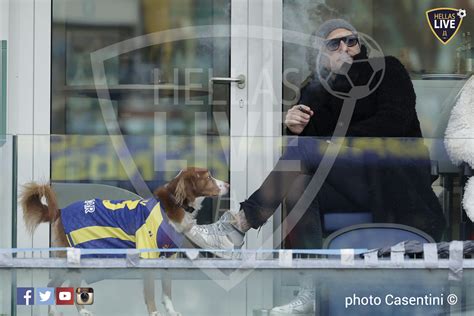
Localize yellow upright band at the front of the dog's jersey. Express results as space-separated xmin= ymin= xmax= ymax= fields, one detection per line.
xmin=135 ymin=203 xmax=163 ymax=259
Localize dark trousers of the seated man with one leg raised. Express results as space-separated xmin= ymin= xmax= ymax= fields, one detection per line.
xmin=241 ymin=137 xmax=375 ymax=228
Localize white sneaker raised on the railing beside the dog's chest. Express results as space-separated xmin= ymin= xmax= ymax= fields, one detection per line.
xmin=184 ymin=211 xmax=245 ymax=258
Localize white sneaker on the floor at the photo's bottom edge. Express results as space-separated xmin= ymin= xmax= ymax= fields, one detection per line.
xmin=270 ymin=287 xmax=316 ymax=316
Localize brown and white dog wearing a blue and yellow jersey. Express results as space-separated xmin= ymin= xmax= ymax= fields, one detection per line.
xmin=20 ymin=167 xmax=229 ymax=316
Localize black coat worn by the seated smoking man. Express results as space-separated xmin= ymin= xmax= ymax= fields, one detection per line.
xmin=287 ymin=48 xmax=445 ymax=240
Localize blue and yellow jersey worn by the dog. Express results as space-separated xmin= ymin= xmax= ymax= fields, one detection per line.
xmin=61 ymin=199 xmax=183 ymax=258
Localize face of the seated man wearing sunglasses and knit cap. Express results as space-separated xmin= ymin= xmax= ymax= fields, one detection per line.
xmin=324 ymin=29 xmax=360 ymax=73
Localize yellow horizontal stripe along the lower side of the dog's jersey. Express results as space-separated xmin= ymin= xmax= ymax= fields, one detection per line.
xmin=69 ymin=226 xmax=135 ymax=245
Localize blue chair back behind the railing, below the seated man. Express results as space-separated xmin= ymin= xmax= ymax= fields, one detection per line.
xmin=318 ymin=223 xmax=438 ymax=315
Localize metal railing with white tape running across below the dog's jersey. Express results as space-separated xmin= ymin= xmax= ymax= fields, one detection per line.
xmin=0 ymin=244 xmax=474 ymax=269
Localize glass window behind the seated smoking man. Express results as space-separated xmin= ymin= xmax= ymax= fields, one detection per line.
xmin=283 ymin=0 xmax=474 ymax=238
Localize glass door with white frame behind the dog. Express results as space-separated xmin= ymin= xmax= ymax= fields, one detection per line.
xmin=51 ymin=0 xmax=247 ymax=223
